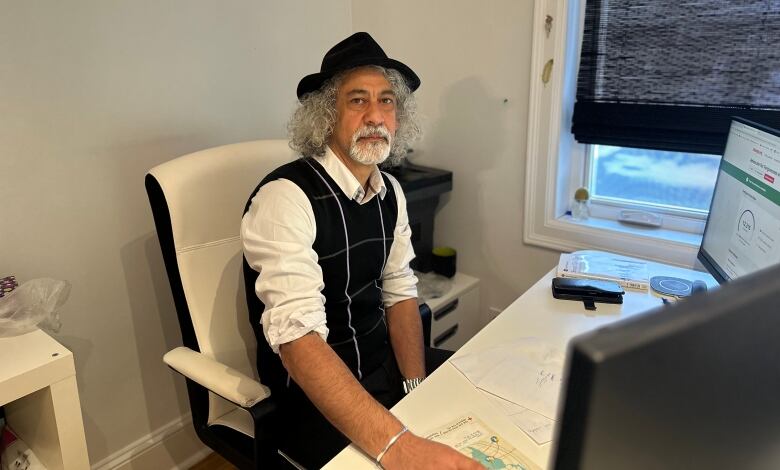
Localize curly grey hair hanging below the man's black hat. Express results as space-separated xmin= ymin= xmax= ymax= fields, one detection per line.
xmin=287 ymin=65 xmax=422 ymax=166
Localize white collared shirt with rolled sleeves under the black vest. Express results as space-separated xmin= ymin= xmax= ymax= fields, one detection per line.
xmin=241 ymin=148 xmax=417 ymax=354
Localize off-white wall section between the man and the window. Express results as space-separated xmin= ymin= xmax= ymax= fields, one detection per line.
xmin=352 ymin=0 xmax=558 ymax=326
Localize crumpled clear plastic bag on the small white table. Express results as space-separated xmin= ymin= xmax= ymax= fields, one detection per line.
xmin=0 ymin=278 xmax=70 ymax=338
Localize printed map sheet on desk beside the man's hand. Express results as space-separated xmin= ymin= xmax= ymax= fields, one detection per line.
xmin=426 ymin=415 xmax=539 ymax=470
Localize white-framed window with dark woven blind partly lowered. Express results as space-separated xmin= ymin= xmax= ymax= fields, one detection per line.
xmin=524 ymin=0 xmax=780 ymax=266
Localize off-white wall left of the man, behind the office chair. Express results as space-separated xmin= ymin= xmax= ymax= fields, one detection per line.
xmin=0 ymin=0 xmax=351 ymax=468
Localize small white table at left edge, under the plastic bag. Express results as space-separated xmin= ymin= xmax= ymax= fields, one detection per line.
xmin=0 ymin=330 xmax=89 ymax=470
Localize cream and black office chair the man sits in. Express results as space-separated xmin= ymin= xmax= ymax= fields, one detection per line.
xmin=146 ymin=140 xmax=296 ymax=469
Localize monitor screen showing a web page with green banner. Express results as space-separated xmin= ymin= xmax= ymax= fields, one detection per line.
xmin=698 ymin=118 xmax=780 ymax=283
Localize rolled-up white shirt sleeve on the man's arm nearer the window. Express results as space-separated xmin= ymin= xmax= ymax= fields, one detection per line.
xmin=382 ymin=176 xmax=417 ymax=308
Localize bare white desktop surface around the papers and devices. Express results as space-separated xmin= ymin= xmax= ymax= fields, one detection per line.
xmin=324 ymin=263 xmax=717 ymax=470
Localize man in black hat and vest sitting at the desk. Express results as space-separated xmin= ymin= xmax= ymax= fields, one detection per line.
xmin=241 ymin=33 xmax=481 ymax=469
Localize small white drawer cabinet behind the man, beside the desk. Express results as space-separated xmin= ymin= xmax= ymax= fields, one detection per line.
xmin=424 ymin=273 xmax=479 ymax=351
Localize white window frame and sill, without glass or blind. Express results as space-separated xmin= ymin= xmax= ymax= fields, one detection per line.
xmin=523 ymin=0 xmax=703 ymax=268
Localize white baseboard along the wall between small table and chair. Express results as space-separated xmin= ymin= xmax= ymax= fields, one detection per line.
xmin=91 ymin=413 xmax=212 ymax=470
